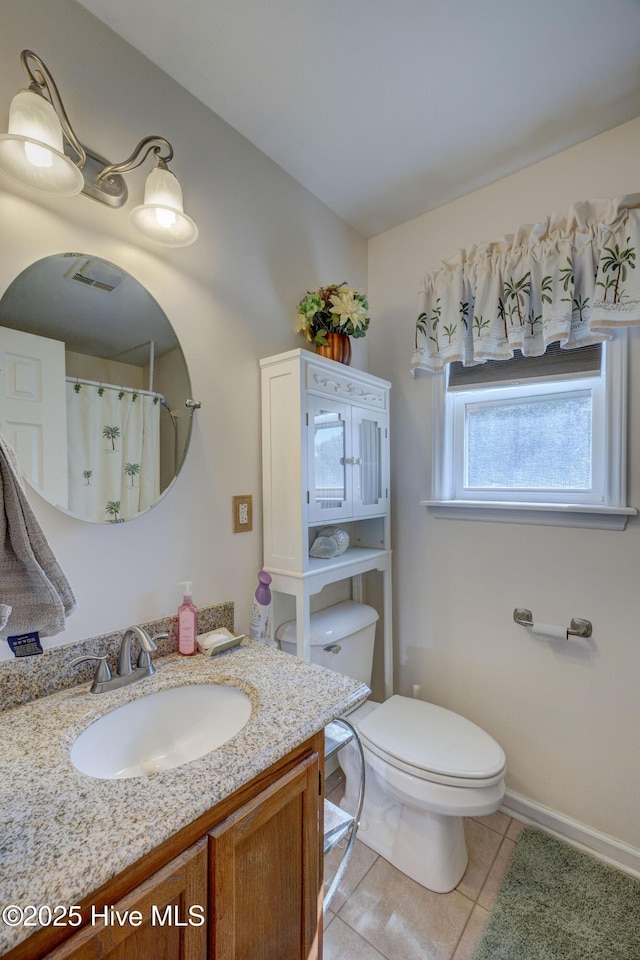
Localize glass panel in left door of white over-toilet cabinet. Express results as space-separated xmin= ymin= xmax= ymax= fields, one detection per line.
xmin=313 ymin=403 xmax=348 ymax=519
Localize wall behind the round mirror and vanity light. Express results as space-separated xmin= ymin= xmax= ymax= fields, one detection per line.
xmin=0 ymin=0 xmax=366 ymax=655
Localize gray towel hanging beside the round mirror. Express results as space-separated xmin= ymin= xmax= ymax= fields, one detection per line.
xmin=0 ymin=434 xmax=76 ymax=637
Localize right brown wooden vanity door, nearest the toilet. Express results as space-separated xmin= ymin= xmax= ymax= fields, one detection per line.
xmin=209 ymin=753 xmax=322 ymax=960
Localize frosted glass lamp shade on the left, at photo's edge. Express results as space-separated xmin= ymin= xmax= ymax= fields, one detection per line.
xmin=0 ymin=90 xmax=84 ymax=197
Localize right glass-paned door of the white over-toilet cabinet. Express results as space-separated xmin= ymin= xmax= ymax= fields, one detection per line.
xmin=351 ymin=407 xmax=389 ymax=517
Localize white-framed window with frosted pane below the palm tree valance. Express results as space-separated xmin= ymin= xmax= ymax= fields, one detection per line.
xmin=425 ymin=332 xmax=636 ymax=529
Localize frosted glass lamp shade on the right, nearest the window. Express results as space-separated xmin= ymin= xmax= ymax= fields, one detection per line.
xmin=129 ymin=167 xmax=198 ymax=247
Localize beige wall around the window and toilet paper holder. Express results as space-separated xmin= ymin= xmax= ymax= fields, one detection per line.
xmin=368 ymin=120 xmax=640 ymax=847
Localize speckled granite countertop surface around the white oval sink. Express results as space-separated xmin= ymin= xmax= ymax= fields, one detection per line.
xmin=0 ymin=640 xmax=369 ymax=956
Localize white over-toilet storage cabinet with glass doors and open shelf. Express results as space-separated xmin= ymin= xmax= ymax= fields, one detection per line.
xmin=260 ymin=350 xmax=393 ymax=697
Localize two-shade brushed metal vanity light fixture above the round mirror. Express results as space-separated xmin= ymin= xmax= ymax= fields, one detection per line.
xmin=0 ymin=50 xmax=198 ymax=247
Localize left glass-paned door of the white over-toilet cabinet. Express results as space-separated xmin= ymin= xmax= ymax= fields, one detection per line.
xmin=308 ymin=397 xmax=353 ymax=523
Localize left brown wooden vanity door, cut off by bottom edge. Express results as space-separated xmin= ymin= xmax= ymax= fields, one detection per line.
xmin=46 ymin=838 xmax=207 ymax=960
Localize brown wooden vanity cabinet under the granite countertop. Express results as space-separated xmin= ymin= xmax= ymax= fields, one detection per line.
xmin=4 ymin=733 xmax=324 ymax=960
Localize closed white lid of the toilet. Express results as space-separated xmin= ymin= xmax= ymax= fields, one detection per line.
xmin=358 ymin=695 xmax=505 ymax=780
